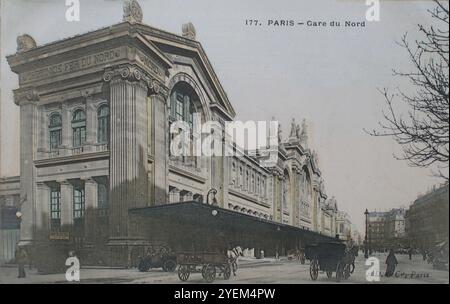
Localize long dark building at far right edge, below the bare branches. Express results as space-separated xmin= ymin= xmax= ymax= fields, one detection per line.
xmin=406 ymin=184 xmax=449 ymax=249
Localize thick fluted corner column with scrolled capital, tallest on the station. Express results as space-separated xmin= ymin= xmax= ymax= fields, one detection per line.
xmin=104 ymin=65 xmax=150 ymax=241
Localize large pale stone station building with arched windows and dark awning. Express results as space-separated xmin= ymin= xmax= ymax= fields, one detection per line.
xmin=2 ymin=4 xmax=337 ymax=266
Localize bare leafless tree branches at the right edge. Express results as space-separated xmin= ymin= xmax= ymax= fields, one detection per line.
xmin=368 ymin=0 xmax=449 ymax=182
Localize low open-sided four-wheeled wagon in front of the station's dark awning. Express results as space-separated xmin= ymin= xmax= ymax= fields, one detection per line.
xmin=177 ymin=251 xmax=235 ymax=283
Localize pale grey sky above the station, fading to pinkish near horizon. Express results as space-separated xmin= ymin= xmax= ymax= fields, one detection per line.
xmin=0 ymin=0 xmax=439 ymax=231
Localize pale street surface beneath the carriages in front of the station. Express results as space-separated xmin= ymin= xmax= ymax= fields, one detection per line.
xmin=0 ymin=254 xmax=449 ymax=284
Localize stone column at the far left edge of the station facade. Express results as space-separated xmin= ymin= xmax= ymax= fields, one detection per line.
xmin=14 ymin=89 xmax=39 ymax=245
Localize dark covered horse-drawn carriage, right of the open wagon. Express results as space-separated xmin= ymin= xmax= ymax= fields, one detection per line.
xmin=305 ymin=242 xmax=355 ymax=282
